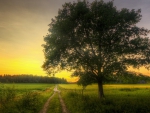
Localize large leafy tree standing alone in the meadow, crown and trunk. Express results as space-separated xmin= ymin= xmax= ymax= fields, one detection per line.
xmin=43 ymin=0 xmax=150 ymax=97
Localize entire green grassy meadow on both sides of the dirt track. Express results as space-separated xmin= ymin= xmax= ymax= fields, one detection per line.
xmin=0 ymin=83 xmax=150 ymax=113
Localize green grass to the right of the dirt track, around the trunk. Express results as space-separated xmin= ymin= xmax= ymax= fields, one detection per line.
xmin=59 ymin=84 xmax=150 ymax=113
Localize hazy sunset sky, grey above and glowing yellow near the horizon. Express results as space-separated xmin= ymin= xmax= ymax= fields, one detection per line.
xmin=0 ymin=0 xmax=150 ymax=80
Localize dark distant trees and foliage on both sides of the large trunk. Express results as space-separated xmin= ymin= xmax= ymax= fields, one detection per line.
xmin=77 ymin=71 xmax=150 ymax=87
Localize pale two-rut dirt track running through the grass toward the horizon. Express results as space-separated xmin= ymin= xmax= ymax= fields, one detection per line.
xmin=39 ymin=85 xmax=69 ymax=113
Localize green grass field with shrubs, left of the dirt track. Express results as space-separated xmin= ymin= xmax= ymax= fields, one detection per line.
xmin=0 ymin=83 xmax=55 ymax=113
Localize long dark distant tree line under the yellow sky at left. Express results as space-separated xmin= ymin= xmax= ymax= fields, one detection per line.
xmin=0 ymin=75 xmax=67 ymax=84
